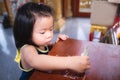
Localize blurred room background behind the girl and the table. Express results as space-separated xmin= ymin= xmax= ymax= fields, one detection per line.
xmin=0 ymin=0 xmax=120 ymax=80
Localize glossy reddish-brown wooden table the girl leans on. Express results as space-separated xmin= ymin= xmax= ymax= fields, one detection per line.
xmin=30 ymin=39 xmax=120 ymax=80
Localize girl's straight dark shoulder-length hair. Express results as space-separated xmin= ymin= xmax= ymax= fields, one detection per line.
xmin=13 ymin=2 xmax=53 ymax=49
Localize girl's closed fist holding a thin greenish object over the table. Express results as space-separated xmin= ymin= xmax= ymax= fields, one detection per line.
xmin=67 ymin=56 xmax=90 ymax=73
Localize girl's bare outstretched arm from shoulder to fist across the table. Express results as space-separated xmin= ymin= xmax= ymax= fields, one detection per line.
xmin=21 ymin=45 xmax=90 ymax=72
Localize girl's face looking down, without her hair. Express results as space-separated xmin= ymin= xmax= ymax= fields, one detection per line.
xmin=32 ymin=16 xmax=53 ymax=47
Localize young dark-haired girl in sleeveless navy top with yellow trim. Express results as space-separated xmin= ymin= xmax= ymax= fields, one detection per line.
xmin=13 ymin=2 xmax=90 ymax=80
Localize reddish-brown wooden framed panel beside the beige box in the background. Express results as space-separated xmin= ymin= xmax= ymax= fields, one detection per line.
xmin=71 ymin=0 xmax=92 ymax=17
